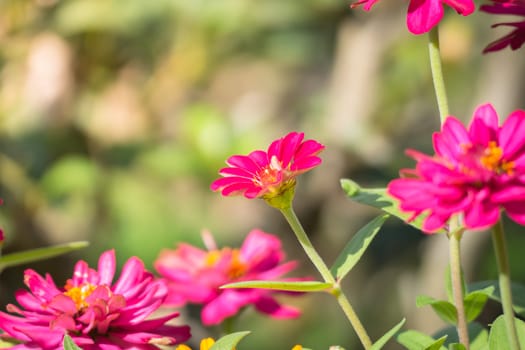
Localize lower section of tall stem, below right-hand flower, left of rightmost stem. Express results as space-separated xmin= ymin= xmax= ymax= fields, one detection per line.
xmin=449 ymin=228 xmax=470 ymax=350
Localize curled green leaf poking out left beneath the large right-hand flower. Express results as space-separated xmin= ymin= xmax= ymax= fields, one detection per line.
xmin=341 ymin=179 xmax=438 ymax=233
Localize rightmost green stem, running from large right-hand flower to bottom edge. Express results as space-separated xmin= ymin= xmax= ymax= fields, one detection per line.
xmin=492 ymin=221 xmax=520 ymax=350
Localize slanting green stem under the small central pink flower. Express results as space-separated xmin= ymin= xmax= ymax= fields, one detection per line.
xmin=279 ymin=206 xmax=372 ymax=349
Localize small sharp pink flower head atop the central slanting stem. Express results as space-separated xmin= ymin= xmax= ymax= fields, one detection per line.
xmin=211 ymin=132 xmax=324 ymax=198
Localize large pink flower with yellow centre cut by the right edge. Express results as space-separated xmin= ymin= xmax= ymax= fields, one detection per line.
xmin=388 ymin=104 xmax=525 ymax=232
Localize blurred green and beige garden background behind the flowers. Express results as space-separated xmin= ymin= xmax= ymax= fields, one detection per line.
xmin=0 ymin=0 xmax=525 ymax=350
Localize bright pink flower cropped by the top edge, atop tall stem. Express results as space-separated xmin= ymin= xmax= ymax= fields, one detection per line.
xmin=351 ymin=0 xmax=476 ymax=34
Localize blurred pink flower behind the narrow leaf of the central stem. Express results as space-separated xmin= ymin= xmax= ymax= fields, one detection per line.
xmin=154 ymin=230 xmax=300 ymax=325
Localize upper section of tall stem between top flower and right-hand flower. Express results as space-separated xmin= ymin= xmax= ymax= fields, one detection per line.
xmin=428 ymin=26 xmax=449 ymax=125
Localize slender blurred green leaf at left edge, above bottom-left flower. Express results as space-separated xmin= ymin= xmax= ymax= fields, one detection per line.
xmin=0 ymin=241 xmax=89 ymax=272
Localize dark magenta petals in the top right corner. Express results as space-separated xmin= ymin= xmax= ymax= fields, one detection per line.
xmin=480 ymin=0 xmax=525 ymax=53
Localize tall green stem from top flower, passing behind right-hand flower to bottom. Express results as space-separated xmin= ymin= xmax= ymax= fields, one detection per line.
xmin=428 ymin=25 xmax=470 ymax=350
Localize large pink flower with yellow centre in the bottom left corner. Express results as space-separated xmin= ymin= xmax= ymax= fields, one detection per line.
xmin=0 ymin=250 xmax=190 ymax=350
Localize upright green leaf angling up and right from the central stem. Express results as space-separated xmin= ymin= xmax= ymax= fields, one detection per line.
xmin=330 ymin=214 xmax=390 ymax=281
